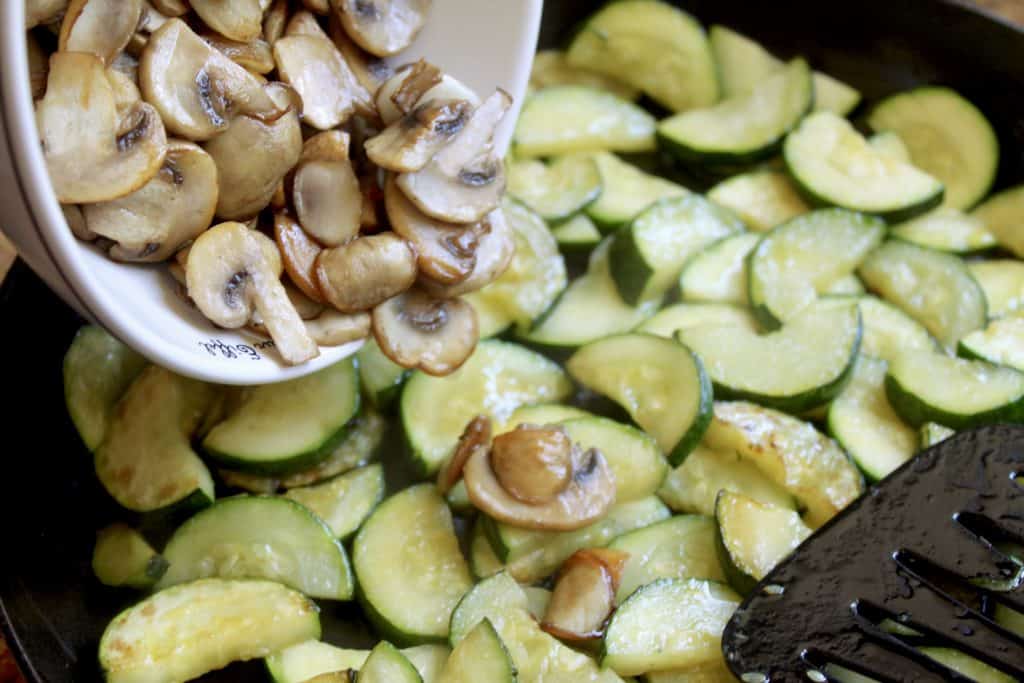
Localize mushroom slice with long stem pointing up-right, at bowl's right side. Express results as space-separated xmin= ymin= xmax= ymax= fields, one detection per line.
xmin=398 ymin=90 xmax=512 ymax=223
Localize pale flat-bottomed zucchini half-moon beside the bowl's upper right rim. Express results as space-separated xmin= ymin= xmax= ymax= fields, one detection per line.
xmin=512 ymin=85 xmax=656 ymax=159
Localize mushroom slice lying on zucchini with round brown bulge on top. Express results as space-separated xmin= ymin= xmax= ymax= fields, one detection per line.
xmin=463 ymin=425 xmax=615 ymax=531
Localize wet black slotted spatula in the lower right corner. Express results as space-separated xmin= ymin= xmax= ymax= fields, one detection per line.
xmin=723 ymin=425 xmax=1024 ymax=683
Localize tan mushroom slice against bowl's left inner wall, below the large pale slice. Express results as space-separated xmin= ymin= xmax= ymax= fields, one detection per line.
xmin=82 ymin=140 xmax=218 ymax=262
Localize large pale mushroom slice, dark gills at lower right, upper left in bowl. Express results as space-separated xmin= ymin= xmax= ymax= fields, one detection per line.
xmin=139 ymin=19 xmax=290 ymax=141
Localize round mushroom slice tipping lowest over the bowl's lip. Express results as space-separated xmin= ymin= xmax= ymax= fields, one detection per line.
xmin=373 ymin=288 xmax=479 ymax=376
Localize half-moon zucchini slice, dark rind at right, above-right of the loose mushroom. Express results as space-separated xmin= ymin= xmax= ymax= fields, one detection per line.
xmin=565 ymin=334 xmax=712 ymax=464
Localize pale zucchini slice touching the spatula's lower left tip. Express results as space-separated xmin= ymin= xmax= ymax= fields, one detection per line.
xmin=601 ymin=579 xmax=739 ymax=676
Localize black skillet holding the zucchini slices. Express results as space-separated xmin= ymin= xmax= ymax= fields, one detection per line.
xmin=6 ymin=0 xmax=1024 ymax=683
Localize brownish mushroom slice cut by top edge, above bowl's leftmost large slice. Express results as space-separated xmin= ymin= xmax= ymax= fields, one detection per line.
xmin=57 ymin=0 xmax=142 ymax=65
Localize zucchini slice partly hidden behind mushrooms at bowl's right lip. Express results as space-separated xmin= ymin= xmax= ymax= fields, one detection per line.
xmin=466 ymin=197 xmax=568 ymax=337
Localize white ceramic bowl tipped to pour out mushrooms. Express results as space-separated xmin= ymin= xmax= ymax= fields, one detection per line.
xmin=0 ymin=0 xmax=542 ymax=384
